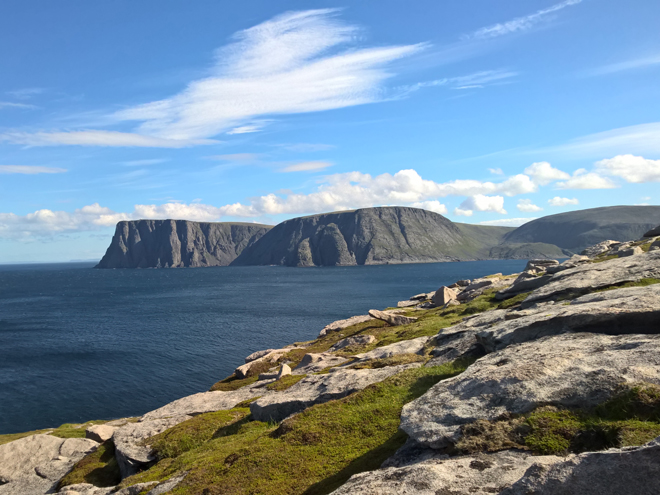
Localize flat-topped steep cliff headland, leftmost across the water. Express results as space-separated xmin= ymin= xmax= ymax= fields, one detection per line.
xmin=96 ymin=220 xmax=271 ymax=268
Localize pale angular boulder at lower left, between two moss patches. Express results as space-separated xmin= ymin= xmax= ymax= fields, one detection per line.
xmin=112 ymin=416 xmax=191 ymax=478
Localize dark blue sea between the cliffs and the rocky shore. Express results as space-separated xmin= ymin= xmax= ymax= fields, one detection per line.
xmin=0 ymin=260 xmax=525 ymax=434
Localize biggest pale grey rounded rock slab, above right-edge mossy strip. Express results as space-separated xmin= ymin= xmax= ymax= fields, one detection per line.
xmin=401 ymin=333 xmax=660 ymax=448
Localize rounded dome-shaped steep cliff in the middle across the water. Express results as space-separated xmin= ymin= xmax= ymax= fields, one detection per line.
xmin=232 ymin=207 xmax=501 ymax=266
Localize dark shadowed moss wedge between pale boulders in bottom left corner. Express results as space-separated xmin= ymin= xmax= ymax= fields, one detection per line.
xmin=58 ymin=440 xmax=121 ymax=490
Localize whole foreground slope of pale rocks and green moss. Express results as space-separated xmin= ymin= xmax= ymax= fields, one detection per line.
xmin=0 ymin=230 xmax=660 ymax=495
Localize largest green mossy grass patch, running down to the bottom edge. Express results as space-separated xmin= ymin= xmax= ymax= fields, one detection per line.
xmin=121 ymin=363 xmax=465 ymax=495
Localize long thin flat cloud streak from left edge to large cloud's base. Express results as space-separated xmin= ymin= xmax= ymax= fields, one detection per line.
xmin=0 ymin=130 xmax=218 ymax=148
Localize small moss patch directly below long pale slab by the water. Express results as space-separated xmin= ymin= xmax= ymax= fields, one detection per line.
xmin=148 ymin=408 xmax=250 ymax=459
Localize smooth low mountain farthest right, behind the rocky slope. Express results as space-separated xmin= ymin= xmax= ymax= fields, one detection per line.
xmin=504 ymin=206 xmax=660 ymax=252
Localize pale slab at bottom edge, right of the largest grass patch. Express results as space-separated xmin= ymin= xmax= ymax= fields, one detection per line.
xmin=332 ymin=451 xmax=560 ymax=495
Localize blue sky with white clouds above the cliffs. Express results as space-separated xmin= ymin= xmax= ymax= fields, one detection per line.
xmin=0 ymin=0 xmax=660 ymax=263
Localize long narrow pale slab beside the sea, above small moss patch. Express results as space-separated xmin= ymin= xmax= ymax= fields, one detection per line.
xmin=140 ymin=376 xmax=276 ymax=421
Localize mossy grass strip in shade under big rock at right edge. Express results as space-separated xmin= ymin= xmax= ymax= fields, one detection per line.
xmin=456 ymin=384 xmax=660 ymax=455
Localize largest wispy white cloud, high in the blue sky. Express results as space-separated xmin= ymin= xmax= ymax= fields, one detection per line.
xmin=115 ymin=9 xmax=425 ymax=140
